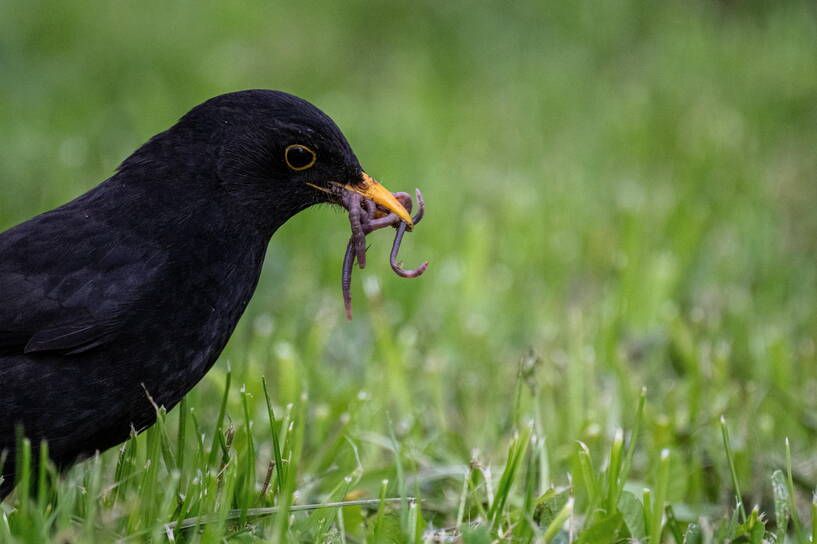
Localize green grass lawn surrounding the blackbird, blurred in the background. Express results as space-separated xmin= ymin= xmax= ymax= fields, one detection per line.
xmin=0 ymin=0 xmax=817 ymax=543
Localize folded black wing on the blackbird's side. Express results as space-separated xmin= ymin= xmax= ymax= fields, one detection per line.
xmin=0 ymin=211 xmax=165 ymax=354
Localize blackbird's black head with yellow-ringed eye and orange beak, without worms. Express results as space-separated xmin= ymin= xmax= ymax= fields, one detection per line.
xmin=155 ymin=90 xmax=411 ymax=234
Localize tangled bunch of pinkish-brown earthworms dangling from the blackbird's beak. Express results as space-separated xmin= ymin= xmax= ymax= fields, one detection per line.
xmin=339 ymin=189 xmax=428 ymax=319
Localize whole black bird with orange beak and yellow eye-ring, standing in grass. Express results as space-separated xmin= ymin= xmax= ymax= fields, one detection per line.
xmin=0 ymin=90 xmax=411 ymax=497
